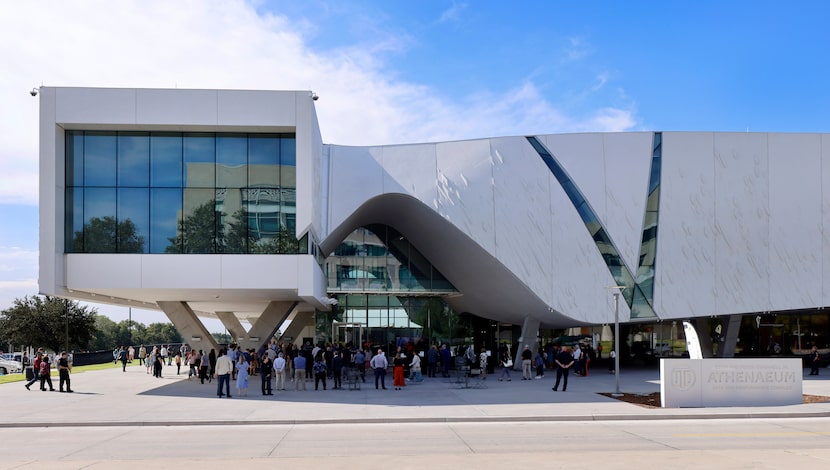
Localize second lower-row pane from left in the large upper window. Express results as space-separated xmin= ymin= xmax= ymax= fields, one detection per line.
xmin=83 ymin=188 xmax=116 ymax=253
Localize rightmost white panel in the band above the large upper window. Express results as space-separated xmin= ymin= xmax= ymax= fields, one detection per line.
xmin=217 ymin=90 xmax=297 ymax=128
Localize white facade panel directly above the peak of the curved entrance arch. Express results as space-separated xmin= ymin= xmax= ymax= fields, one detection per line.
xmin=383 ymin=144 xmax=438 ymax=202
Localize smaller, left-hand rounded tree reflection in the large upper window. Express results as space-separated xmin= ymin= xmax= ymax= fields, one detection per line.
xmin=72 ymin=215 xmax=144 ymax=253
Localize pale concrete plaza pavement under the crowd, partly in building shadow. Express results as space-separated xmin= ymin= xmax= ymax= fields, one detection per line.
xmin=0 ymin=366 xmax=830 ymax=428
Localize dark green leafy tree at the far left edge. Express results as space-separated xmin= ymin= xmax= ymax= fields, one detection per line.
xmin=0 ymin=295 xmax=97 ymax=351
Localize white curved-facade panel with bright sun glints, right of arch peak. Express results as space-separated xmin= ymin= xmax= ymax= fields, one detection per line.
xmin=436 ymin=140 xmax=495 ymax=254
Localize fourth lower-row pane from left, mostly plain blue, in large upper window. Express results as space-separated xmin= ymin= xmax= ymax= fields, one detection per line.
xmin=150 ymin=188 xmax=182 ymax=253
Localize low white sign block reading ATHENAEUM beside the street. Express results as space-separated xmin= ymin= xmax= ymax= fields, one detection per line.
xmin=660 ymin=358 xmax=803 ymax=408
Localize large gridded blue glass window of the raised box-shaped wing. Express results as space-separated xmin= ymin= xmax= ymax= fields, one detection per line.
xmin=64 ymin=131 xmax=308 ymax=254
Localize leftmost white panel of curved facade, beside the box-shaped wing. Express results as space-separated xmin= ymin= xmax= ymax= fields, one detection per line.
xmin=329 ymin=145 xmax=383 ymax=229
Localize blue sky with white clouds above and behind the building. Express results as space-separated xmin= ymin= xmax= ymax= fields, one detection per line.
xmin=0 ymin=0 xmax=830 ymax=331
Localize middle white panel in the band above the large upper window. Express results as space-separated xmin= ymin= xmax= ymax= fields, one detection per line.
xmin=135 ymin=89 xmax=219 ymax=126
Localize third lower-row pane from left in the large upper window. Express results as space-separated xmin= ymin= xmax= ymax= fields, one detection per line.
xmin=116 ymin=188 xmax=150 ymax=253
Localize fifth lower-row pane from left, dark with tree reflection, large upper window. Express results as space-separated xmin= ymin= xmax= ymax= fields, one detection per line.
xmin=182 ymin=189 xmax=216 ymax=253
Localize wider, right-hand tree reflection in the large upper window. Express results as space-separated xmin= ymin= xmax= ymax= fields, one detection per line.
xmin=165 ymin=200 xmax=300 ymax=254
